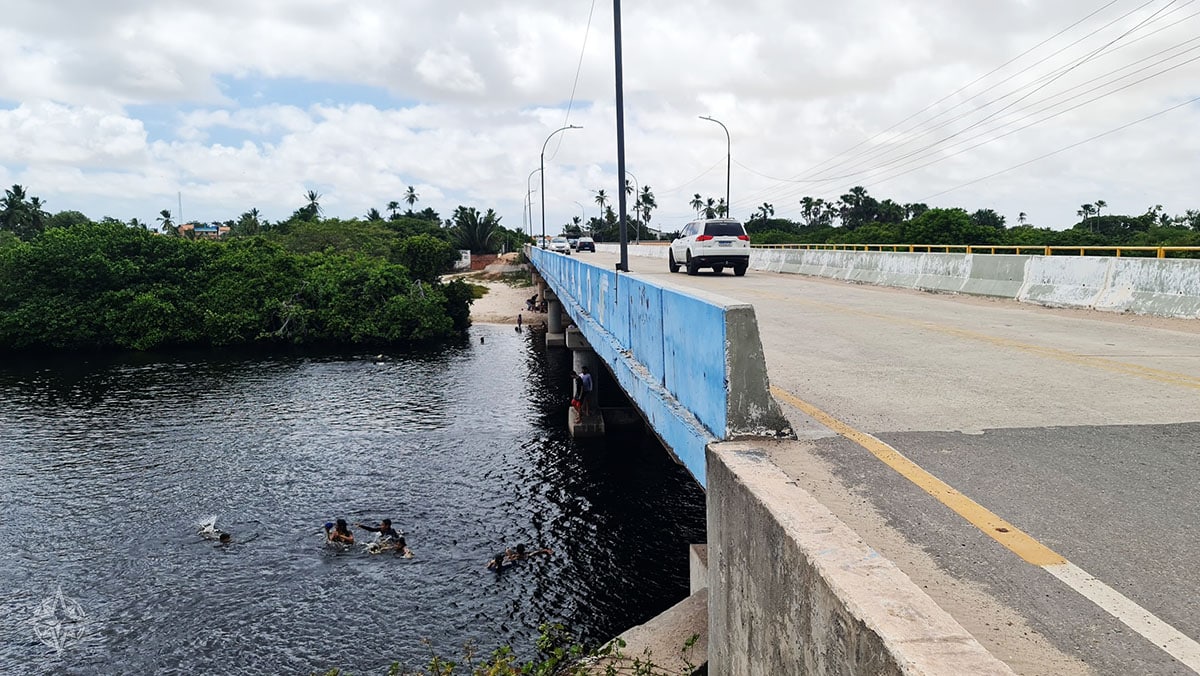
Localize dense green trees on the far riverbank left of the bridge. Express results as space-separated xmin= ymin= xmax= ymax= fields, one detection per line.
xmin=0 ymin=185 xmax=535 ymax=351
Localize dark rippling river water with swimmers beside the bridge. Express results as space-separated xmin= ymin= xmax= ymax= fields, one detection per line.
xmin=0 ymin=327 xmax=704 ymax=674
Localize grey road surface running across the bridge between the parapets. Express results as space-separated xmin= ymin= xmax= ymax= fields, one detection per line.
xmin=576 ymin=253 xmax=1200 ymax=675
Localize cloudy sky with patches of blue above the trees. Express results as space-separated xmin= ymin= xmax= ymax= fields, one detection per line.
xmin=0 ymin=0 xmax=1200 ymax=234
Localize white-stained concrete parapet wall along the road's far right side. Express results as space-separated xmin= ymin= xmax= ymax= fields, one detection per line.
xmin=598 ymin=245 xmax=1200 ymax=318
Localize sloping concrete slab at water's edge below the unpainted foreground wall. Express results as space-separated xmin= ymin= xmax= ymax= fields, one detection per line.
xmin=593 ymin=590 xmax=705 ymax=674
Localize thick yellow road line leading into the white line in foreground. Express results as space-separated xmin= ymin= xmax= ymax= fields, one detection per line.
xmin=770 ymin=385 xmax=1067 ymax=566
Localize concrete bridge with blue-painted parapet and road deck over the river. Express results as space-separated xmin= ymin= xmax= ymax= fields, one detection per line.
xmin=530 ymin=246 xmax=1200 ymax=674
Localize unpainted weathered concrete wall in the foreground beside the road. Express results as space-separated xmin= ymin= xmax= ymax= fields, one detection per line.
xmin=708 ymin=443 xmax=1013 ymax=676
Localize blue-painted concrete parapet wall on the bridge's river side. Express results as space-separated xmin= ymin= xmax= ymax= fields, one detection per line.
xmin=529 ymin=247 xmax=791 ymax=484
